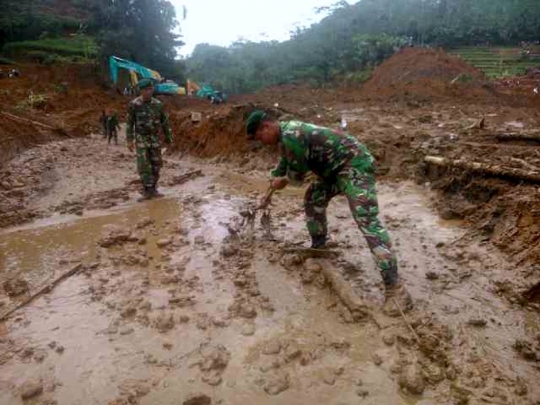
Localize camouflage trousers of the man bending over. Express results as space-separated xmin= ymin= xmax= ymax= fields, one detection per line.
xmin=304 ymin=157 xmax=398 ymax=286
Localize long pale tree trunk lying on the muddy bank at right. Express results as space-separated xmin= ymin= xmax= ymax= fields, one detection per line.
xmin=424 ymin=156 xmax=540 ymax=183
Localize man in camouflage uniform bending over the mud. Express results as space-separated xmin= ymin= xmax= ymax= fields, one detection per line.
xmin=247 ymin=111 xmax=412 ymax=316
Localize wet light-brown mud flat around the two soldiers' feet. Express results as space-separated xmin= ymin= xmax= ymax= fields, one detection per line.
xmin=0 ymin=111 xmax=540 ymax=404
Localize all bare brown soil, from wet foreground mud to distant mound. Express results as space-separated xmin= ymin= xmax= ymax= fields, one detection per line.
xmin=0 ymin=50 xmax=540 ymax=405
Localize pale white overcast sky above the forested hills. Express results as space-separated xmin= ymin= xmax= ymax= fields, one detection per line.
xmin=170 ymin=0 xmax=354 ymax=56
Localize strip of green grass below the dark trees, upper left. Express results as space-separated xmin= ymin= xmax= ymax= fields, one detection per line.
xmin=4 ymin=35 xmax=98 ymax=59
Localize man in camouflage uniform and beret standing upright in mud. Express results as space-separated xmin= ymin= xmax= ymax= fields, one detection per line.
xmin=126 ymin=79 xmax=172 ymax=200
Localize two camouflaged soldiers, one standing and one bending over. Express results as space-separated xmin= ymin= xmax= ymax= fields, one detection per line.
xmin=120 ymin=79 xmax=412 ymax=316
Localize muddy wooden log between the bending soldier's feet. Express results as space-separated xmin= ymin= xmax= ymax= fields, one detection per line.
xmin=312 ymin=259 xmax=369 ymax=320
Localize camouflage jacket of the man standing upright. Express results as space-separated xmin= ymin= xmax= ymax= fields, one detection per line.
xmin=126 ymin=97 xmax=172 ymax=148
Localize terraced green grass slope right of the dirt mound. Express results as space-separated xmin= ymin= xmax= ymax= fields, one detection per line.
xmin=450 ymin=47 xmax=540 ymax=77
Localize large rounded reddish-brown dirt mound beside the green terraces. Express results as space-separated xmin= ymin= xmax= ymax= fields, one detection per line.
xmin=362 ymin=48 xmax=502 ymax=101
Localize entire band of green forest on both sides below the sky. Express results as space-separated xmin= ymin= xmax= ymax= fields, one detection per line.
xmin=0 ymin=0 xmax=540 ymax=93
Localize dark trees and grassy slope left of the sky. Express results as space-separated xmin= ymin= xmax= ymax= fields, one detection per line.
xmin=0 ymin=0 xmax=184 ymax=77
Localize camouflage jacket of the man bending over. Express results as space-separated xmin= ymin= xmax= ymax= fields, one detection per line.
xmin=271 ymin=121 xmax=374 ymax=182
